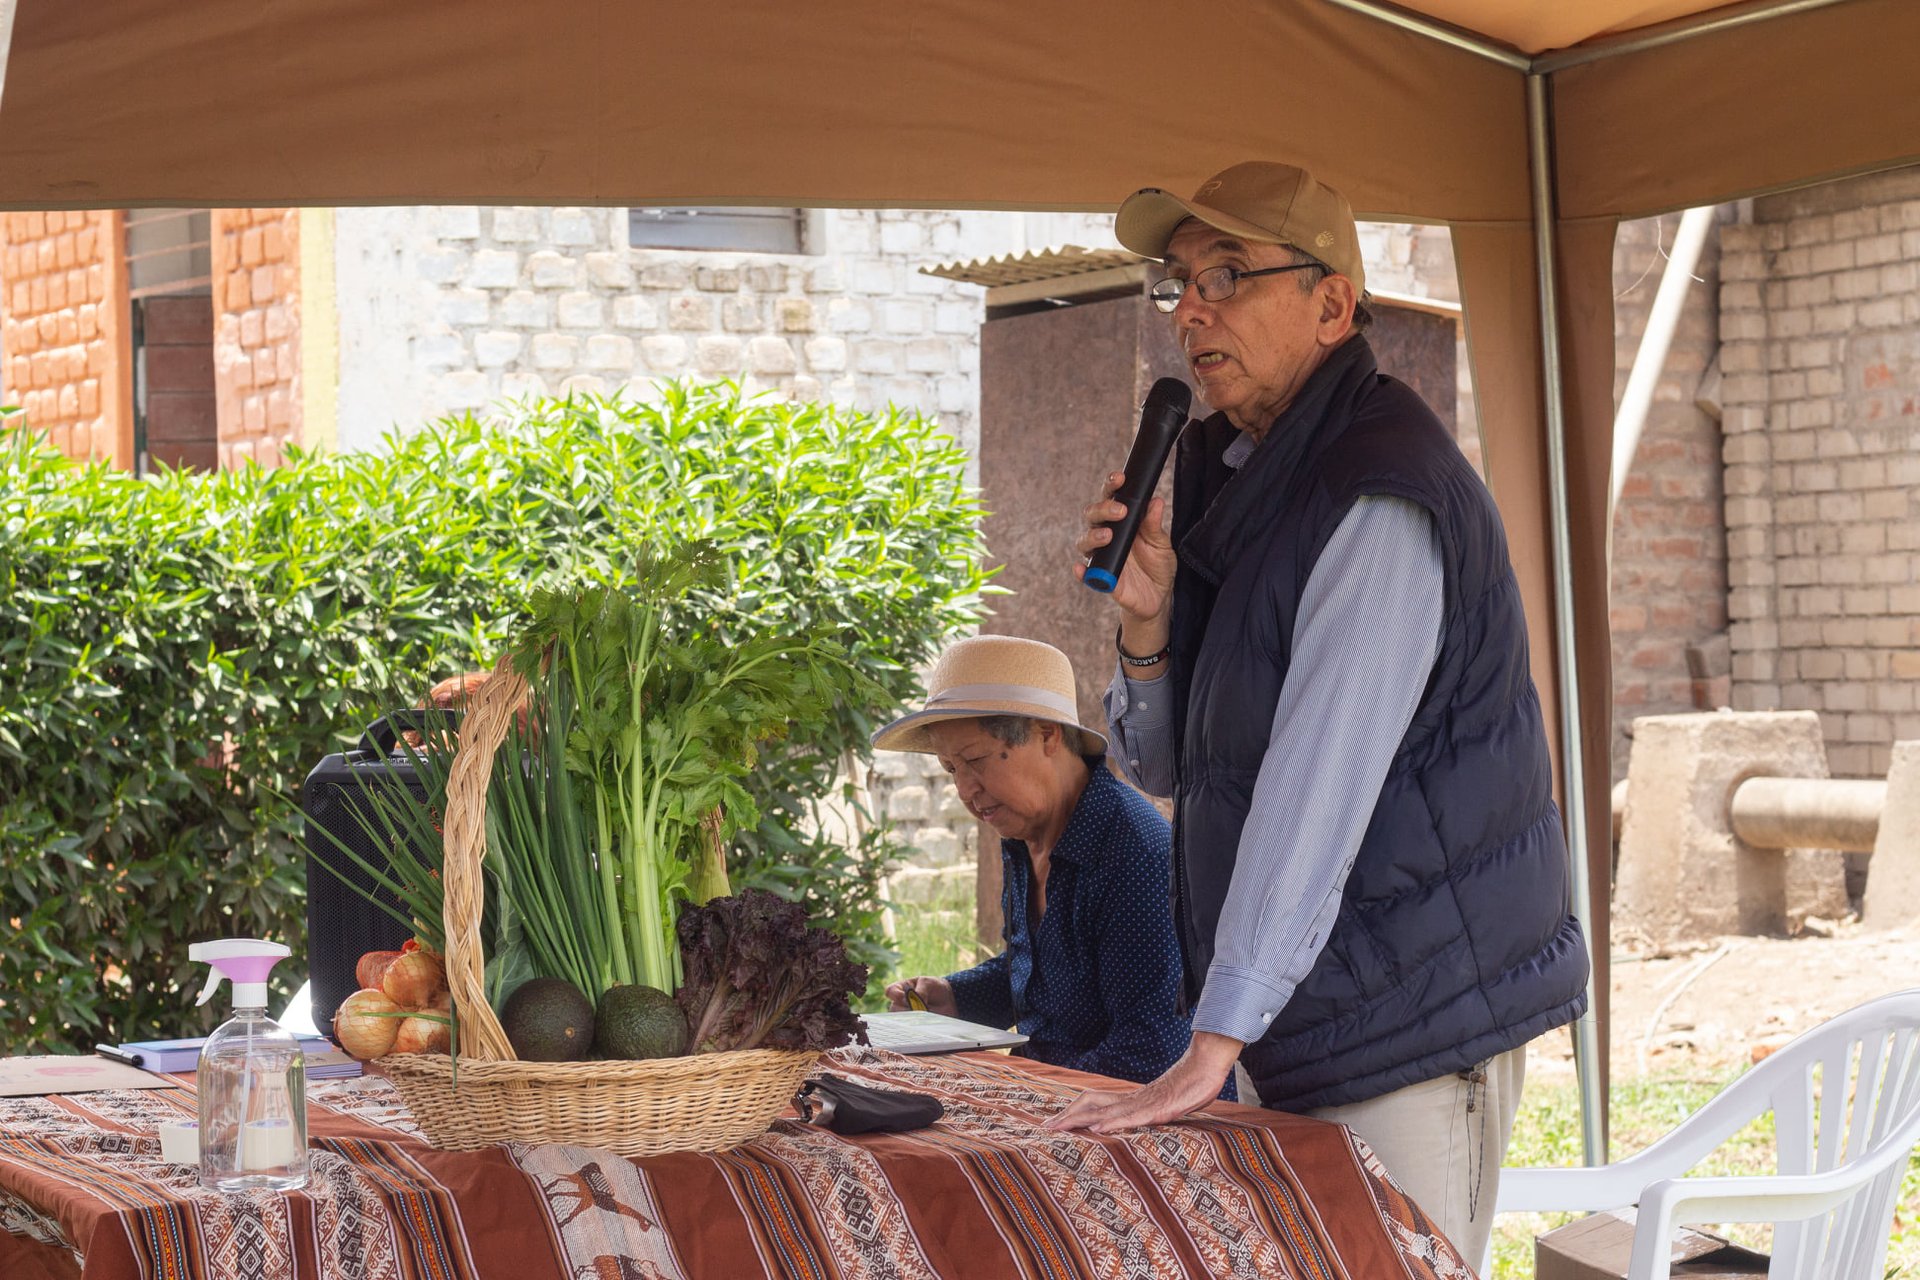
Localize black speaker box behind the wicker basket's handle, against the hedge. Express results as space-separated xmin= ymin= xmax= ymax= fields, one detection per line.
xmin=300 ymin=712 xmax=457 ymax=1034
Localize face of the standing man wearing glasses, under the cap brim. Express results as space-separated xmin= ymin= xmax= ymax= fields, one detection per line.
xmin=1165 ymin=219 xmax=1352 ymax=436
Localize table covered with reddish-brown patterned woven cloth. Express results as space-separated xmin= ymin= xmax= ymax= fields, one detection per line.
xmin=0 ymin=1048 xmax=1473 ymax=1280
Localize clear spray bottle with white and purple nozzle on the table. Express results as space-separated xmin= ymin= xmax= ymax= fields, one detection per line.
xmin=186 ymin=938 xmax=307 ymax=1192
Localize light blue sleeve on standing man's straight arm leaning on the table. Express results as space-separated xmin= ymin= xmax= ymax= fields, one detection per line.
xmin=1192 ymin=497 xmax=1446 ymax=1042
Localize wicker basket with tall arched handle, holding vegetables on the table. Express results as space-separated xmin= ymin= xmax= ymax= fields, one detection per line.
xmin=380 ymin=660 xmax=820 ymax=1155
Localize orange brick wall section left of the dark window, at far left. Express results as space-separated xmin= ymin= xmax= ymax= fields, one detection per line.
xmin=0 ymin=209 xmax=132 ymax=466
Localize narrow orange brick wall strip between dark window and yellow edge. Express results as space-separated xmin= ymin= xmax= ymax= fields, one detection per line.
xmin=213 ymin=209 xmax=300 ymax=468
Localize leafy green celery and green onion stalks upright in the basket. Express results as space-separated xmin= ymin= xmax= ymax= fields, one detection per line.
xmin=510 ymin=543 xmax=864 ymax=996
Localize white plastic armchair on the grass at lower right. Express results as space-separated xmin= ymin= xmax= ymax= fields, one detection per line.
xmin=1500 ymin=988 xmax=1920 ymax=1280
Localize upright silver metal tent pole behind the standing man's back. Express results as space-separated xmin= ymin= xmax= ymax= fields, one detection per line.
xmin=1526 ymin=73 xmax=1607 ymax=1165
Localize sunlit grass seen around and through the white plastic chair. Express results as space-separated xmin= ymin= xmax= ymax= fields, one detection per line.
xmin=1494 ymin=1071 xmax=1920 ymax=1280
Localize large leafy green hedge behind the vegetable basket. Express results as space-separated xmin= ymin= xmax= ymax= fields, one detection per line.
xmin=0 ymin=386 xmax=985 ymax=1054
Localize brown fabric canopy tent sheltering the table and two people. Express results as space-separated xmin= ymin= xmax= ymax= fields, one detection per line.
xmin=0 ymin=0 xmax=1920 ymax=1157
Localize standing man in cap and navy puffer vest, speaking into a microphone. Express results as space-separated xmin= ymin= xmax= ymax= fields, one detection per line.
xmin=1050 ymin=161 xmax=1588 ymax=1259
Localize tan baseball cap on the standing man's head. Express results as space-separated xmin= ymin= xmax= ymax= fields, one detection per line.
xmin=1114 ymin=159 xmax=1367 ymax=294
